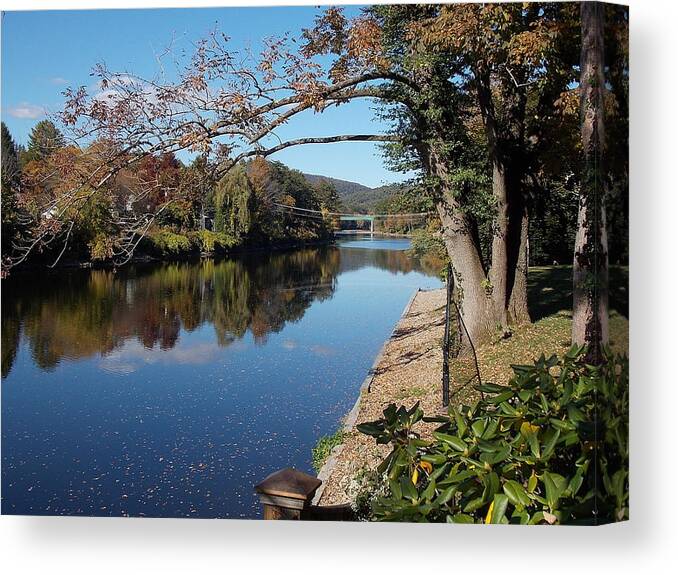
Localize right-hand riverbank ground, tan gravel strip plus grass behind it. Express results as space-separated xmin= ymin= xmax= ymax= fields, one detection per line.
xmin=316 ymin=266 xmax=629 ymax=505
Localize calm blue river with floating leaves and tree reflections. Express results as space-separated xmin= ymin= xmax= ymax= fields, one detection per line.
xmin=2 ymin=237 xmax=441 ymax=518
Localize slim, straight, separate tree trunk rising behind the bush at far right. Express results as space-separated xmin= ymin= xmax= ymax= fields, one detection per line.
xmin=572 ymin=2 xmax=608 ymax=363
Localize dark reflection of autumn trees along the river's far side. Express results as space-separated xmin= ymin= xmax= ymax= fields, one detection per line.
xmin=2 ymin=240 xmax=440 ymax=378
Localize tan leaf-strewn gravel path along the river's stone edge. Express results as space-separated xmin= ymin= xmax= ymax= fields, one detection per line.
xmin=316 ymin=289 xmax=445 ymax=505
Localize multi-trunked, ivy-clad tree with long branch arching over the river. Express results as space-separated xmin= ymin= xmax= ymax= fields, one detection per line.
xmin=5 ymin=3 xmax=628 ymax=358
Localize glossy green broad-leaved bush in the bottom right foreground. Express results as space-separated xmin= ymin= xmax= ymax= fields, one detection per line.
xmin=358 ymin=347 xmax=628 ymax=524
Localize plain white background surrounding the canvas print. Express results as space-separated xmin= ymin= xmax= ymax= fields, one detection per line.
xmin=0 ymin=0 xmax=678 ymax=575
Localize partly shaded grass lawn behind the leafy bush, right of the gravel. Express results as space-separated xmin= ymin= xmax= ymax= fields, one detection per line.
xmin=450 ymin=266 xmax=629 ymax=402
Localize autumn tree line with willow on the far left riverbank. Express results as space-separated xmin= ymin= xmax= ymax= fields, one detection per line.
xmin=2 ymin=120 xmax=341 ymax=266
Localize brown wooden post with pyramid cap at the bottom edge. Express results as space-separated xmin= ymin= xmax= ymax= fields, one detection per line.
xmin=254 ymin=467 xmax=322 ymax=520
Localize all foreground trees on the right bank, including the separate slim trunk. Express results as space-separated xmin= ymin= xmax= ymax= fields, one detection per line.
xmin=0 ymin=2 xmax=628 ymax=359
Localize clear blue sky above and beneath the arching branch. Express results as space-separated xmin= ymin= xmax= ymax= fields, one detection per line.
xmin=2 ymin=7 xmax=404 ymax=186
